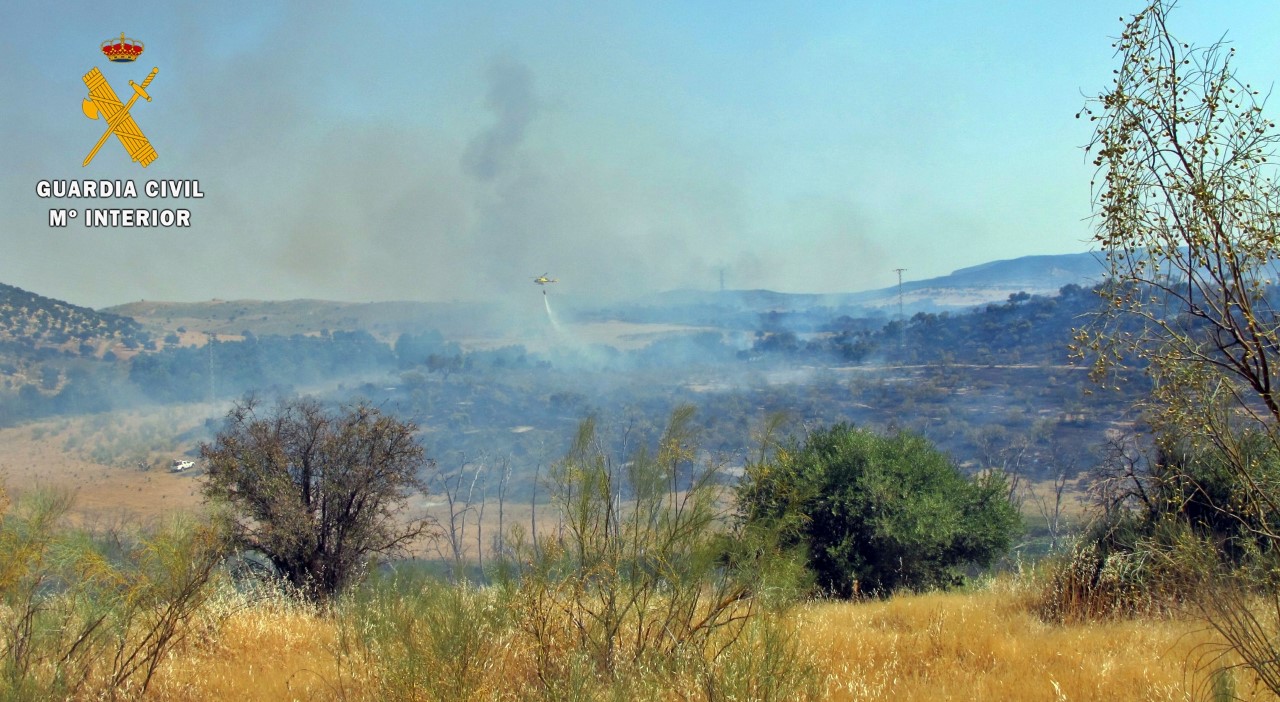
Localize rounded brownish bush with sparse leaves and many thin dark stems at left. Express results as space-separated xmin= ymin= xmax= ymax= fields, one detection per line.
xmin=200 ymin=398 xmax=431 ymax=598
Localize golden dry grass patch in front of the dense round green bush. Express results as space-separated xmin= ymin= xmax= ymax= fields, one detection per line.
xmin=796 ymin=580 xmax=1249 ymax=701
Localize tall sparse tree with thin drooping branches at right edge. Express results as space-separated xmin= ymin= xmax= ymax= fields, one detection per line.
xmin=1078 ymin=0 xmax=1280 ymax=693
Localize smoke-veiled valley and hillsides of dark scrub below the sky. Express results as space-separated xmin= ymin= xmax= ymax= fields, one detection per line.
xmin=0 ymin=248 xmax=1129 ymax=527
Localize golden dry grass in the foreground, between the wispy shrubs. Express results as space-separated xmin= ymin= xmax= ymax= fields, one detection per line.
xmin=120 ymin=579 xmax=1265 ymax=702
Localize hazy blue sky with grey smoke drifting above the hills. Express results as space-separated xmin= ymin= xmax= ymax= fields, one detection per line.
xmin=0 ymin=0 xmax=1280 ymax=306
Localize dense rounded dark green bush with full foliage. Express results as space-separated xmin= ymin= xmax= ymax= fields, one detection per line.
xmin=737 ymin=424 xmax=1020 ymax=597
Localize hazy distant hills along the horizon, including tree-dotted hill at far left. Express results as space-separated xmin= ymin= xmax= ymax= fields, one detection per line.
xmin=0 ymin=248 xmax=1105 ymax=407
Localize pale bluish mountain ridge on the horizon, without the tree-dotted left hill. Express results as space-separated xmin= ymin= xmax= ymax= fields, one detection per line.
xmin=94 ymin=252 xmax=1103 ymax=343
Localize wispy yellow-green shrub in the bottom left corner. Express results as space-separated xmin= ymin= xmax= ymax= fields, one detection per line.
xmin=0 ymin=492 xmax=224 ymax=699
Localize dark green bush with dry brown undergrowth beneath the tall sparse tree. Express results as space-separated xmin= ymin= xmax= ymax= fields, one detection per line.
xmin=1038 ymin=434 xmax=1280 ymax=621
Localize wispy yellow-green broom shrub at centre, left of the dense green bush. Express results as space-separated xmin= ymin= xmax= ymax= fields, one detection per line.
xmin=517 ymin=406 xmax=790 ymax=694
